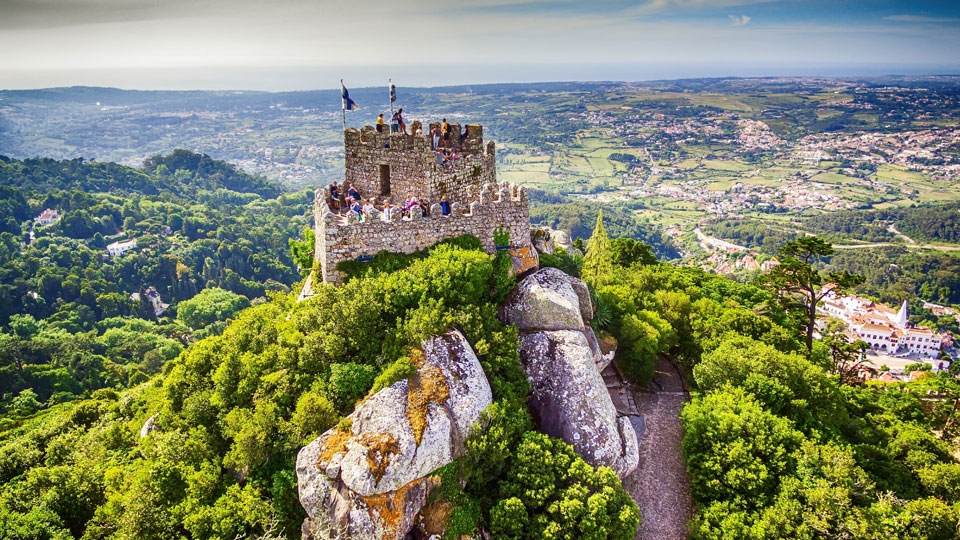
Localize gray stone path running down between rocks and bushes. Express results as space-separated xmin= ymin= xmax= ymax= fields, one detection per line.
xmin=603 ymin=360 xmax=694 ymax=540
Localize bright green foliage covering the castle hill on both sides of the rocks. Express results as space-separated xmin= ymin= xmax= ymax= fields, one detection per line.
xmin=0 ymin=223 xmax=960 ymax=540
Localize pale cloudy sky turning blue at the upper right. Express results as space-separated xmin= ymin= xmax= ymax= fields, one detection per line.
xmin=0 ymin=0 xmax=960 ymax=91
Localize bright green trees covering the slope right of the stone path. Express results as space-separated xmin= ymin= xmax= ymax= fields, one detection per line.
xmin=584 ymin=233 xmax=960 ymax=540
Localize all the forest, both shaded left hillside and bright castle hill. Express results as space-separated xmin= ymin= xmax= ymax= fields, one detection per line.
xmin=0 ymin=151 xmax=960 ymax=540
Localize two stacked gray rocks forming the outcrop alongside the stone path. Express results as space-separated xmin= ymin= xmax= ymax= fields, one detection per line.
xmin=500 ymin=268 xmax=639 ymax=478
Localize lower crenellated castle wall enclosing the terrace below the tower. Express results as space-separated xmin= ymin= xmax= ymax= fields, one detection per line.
xmin=314 ymin=184 xmax=530 ymax=285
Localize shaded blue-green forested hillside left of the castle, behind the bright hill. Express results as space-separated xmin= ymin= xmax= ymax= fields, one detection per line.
xmin=0 ymin=150 xmax=312 ymax=414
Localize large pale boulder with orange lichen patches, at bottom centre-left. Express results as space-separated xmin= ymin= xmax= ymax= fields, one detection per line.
xmin=297 ymin=330 xmax=492 ymax=540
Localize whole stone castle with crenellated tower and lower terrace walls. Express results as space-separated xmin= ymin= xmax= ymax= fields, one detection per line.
xmin=312 ymin=122 xmax=537 ymax=285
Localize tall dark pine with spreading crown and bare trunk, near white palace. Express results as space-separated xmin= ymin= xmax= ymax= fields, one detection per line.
xmin=760 ymin=236 xmax=863 ymax=351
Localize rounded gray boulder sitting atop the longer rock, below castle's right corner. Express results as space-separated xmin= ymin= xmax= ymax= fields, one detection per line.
xmin=500 ymin=268 xmax=589 ymax=331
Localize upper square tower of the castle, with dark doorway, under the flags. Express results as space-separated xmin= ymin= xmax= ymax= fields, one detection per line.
xmin=343 ymin=122 xmax=497 ymax=202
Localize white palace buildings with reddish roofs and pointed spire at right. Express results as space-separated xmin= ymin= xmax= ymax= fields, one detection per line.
xmin=818 ymin=293 xmax=950 ymax=359
